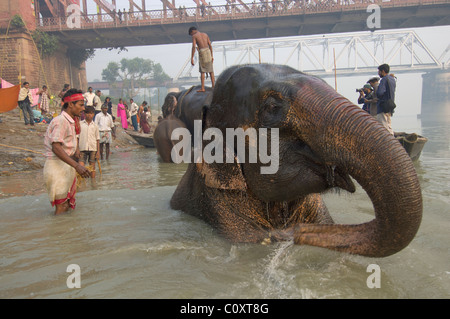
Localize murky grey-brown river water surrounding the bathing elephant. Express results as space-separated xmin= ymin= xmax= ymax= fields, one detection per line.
xmin=0 ymin=116 xmax=450 ymax=298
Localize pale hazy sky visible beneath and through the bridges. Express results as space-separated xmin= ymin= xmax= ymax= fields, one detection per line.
xmin=83 ymin=0 xmax=450 ymax=115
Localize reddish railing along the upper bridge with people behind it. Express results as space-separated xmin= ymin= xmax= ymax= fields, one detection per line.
xmin=37 ymin=0 xmax=449 ymax=31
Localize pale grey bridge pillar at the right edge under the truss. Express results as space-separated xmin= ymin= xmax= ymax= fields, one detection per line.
xmin=420 ymin=70 xmax=450 ymax=121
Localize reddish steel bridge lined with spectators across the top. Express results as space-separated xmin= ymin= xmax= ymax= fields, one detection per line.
xmin=35 ymin=0 xmax=450 ymax=48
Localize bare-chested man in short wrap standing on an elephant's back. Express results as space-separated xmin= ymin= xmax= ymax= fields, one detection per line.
xmin=189 ymin=27 xmax=215 ymax=92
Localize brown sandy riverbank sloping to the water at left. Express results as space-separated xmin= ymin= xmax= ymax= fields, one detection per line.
xmin=0 ymin=108 xmax=152 ymax=198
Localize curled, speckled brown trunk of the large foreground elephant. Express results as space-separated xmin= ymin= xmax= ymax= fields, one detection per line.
xmin=292 ymin=83 xmax=422 ymax=257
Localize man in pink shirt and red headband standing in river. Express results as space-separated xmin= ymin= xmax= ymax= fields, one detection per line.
xmin=44 ymin=89 xmax=91 ymax=215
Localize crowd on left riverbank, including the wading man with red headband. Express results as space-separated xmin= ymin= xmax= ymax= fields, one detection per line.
xmin=14 ymin=82 xmax=152 ymax=215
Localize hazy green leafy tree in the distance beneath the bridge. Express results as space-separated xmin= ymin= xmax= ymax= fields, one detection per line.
xmin=102 ymin=58 xmax=170 ymax=98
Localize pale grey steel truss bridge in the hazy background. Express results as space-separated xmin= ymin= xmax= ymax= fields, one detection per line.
xmin=174 ymin=31 xmax=450 ymax=83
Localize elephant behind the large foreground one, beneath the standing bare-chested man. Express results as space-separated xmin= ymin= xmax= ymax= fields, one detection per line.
xmin=153 ymin=86 xmax=212 ymax=163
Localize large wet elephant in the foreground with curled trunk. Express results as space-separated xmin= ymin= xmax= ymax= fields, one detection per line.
xmin=170 ymin=64 xmax=422 ymax=257
